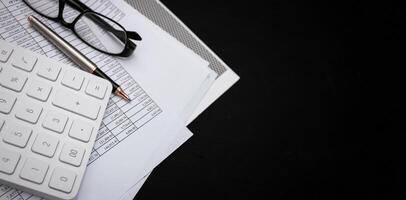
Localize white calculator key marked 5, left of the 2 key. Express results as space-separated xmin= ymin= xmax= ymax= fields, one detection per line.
xmin=3 ymin=122 xmax=32 ymax=148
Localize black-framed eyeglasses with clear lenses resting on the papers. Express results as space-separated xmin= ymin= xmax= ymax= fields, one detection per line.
xmin=23 ymin=0 xmax=142 ymax=57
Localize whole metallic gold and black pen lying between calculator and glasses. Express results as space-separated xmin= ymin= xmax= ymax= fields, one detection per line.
xmin=28 ymin=15 xmax=130 ymax=101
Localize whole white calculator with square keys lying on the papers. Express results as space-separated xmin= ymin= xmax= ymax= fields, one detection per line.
xmin=0 ymin=40 xmax=112 ymax=199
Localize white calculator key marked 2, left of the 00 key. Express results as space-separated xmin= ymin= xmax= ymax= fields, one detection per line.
xmin=32 ymin=134 xmax=59 ymax=158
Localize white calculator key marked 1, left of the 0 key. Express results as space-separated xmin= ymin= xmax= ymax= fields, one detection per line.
xmin=20 ymin=158 xmax=49 ymax=184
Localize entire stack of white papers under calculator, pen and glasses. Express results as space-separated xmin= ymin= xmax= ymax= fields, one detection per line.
xmin=0 ymin=0 xmax=238 ymax=200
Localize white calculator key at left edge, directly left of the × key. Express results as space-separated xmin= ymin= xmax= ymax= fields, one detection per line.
xmin=0 ymin=68 xmax=27 ymax=92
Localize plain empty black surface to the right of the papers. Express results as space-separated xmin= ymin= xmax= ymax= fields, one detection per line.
xmin=136 ymin=0 xmax=406 ymax=200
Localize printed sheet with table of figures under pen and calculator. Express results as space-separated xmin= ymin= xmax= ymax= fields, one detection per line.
xmin=0 ymin=0 xmax=162 ymax=164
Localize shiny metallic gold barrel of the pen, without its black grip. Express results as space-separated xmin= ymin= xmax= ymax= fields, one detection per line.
xmin=28 ymin=16 xmax=98 ymax=73
